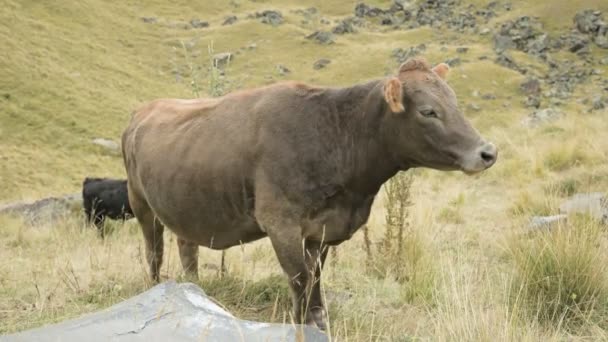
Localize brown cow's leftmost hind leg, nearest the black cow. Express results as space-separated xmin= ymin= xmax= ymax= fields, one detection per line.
xmin=129 ymin=191 xmax=165 ymax=282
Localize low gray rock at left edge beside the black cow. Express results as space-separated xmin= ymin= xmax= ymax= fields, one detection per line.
xmin=0 ymin=193 xmax=82 ymax=225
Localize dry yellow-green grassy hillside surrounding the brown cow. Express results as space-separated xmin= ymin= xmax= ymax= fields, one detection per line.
xmin=0 ymin=0 xmax=608 ymax=341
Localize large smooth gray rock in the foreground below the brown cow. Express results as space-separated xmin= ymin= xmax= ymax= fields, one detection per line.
xmin=0 ymin=281 xmax=329 ymax=342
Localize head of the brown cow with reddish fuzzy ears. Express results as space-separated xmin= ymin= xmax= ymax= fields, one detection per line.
xmin=384 ymin=58 xmax=497 ymax=174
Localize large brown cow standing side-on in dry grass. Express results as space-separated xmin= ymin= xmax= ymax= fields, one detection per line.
xmin=122 ymin=58 xmax=497 ymax=329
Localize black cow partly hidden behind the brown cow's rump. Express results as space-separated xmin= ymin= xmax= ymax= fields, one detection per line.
xmin=82 ymin=177 xmax=133 ymax=238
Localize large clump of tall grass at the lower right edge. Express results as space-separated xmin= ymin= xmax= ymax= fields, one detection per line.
xmin=508 ymin=218 xmax=608 ymax=328
